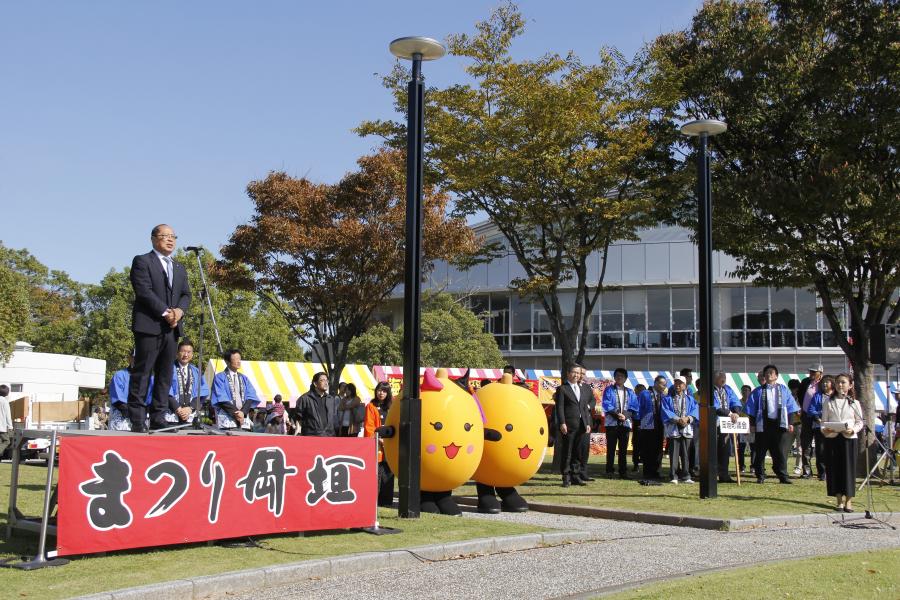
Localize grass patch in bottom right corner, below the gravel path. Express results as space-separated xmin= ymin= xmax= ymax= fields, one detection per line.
xmin=603 ymin=549 xmax=900 ymax=600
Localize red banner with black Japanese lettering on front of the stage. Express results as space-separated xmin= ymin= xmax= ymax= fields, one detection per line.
xmin=57 ymin=435 xmax=378 ymax=556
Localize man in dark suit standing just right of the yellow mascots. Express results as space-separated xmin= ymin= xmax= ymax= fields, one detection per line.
xmin=553 ymin=365 xmax=594 ymax=487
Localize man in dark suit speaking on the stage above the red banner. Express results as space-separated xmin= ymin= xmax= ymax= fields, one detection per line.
xmin=128 ymin=225 xmax=191 ymax=431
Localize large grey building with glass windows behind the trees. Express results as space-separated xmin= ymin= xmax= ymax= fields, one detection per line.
xmin=391 ymin=223 xmax=847 ymax=372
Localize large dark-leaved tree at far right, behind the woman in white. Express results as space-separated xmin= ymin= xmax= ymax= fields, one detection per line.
xmin=648 ymin=0 xmax=900 ymax=440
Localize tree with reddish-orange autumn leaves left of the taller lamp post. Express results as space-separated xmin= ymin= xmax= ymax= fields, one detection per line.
xmin=218 ymin=150 xmax=475 ymax=389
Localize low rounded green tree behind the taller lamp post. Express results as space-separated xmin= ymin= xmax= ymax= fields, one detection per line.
xmin=348 ymin=293 xmax=503 ymax=369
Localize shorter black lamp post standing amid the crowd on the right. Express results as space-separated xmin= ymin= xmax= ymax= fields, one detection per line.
xmin=681 ymin=119 xmax=728 ymax=498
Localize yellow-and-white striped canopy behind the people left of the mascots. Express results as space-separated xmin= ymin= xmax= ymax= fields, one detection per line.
xmin=206 ymin=359 xmax=378 ymax=406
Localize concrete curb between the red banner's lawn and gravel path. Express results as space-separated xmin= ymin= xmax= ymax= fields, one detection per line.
xmin=72 ymin=531 xmax=594 ymax=600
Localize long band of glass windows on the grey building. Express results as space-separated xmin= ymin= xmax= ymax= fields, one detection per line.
xmin=468 ymin=285 xmax=837 ymax=351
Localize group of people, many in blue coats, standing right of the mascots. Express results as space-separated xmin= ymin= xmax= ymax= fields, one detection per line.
xmin=551 ymin=365 xmax=896 ymax=512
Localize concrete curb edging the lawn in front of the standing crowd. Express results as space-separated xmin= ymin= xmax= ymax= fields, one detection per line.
xmin=456 ymin=496 xmax=900 ymax=531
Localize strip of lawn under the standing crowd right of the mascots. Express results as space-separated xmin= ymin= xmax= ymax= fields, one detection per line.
xmin=454 ymin=455 xmax=900 ymax=519
